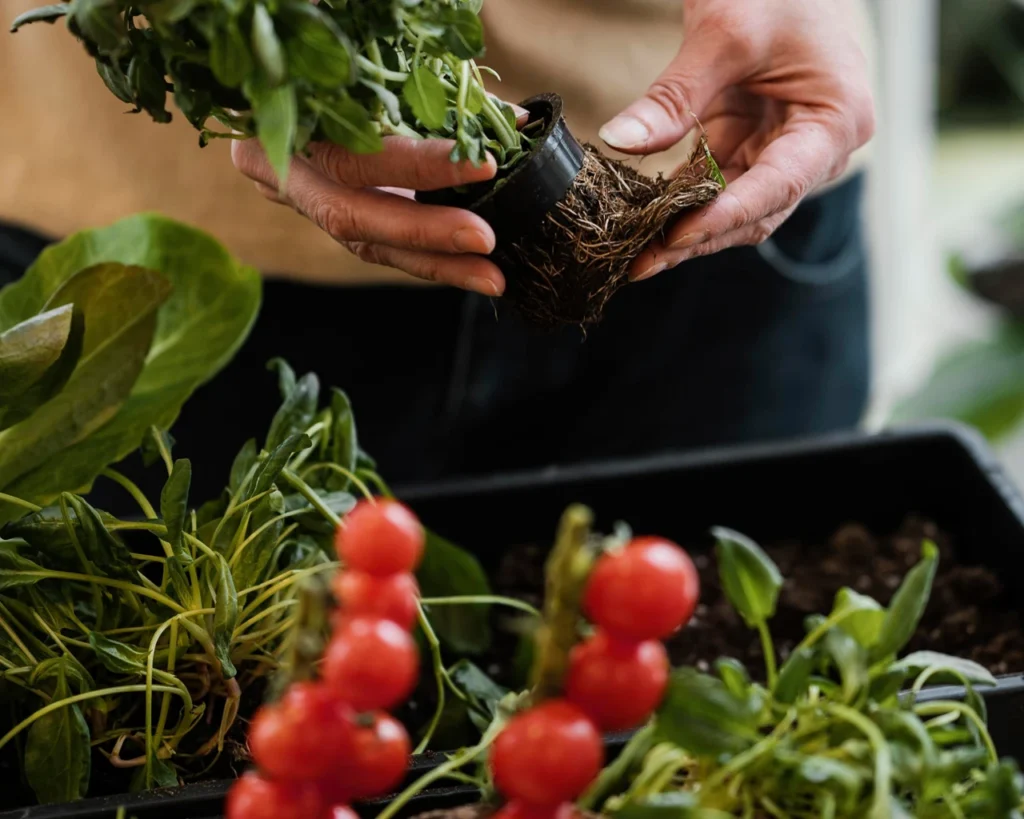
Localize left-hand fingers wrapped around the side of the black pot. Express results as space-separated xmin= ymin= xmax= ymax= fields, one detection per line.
xmin=231 ymin=136 xmax=505 ymax=296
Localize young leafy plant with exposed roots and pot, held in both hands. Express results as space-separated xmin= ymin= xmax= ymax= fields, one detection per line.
xmin=11 ymin=0 xmax=724 ymax=326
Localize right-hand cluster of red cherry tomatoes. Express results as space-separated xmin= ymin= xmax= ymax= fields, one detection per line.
xmin=490 ymin=537 xmax=699 ymax=819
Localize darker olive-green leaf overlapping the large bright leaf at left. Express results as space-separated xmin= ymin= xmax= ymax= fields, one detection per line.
xmin=0 ymin=263 xmax=170 ymax=499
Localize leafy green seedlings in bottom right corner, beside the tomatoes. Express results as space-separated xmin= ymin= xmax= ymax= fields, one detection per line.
xmin=587 ymin=530 xmax=1024 ymax=819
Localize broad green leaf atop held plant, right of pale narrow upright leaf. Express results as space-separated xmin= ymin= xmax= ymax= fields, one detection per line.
xmin=285 ymin=3 xmax=356 ymax=88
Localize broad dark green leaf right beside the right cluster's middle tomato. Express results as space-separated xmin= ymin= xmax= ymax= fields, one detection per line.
xmin=656 ymin=669 xmax=761 ymax=758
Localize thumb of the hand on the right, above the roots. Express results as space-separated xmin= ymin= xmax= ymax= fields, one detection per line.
xmin=599 ymin=31 xmax=734 ymax=154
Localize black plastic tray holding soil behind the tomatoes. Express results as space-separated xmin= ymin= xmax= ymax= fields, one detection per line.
xmin=6 ymin=424 xmax=1024 ymax=819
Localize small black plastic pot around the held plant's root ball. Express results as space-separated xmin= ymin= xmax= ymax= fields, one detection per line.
xmin=416 ymin=94 xmax=584 ymax=270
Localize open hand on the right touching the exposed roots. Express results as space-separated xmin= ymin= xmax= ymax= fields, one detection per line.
xmin=600 ymin=0 xmax=874 ymax=282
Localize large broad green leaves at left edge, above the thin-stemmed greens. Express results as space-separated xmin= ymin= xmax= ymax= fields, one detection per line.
xmin=0 ymin=215 xmax=260 ymax=523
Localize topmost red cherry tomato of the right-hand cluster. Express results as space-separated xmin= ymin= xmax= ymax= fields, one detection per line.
xmin=584 ymin=537 xmax=700 ymax=641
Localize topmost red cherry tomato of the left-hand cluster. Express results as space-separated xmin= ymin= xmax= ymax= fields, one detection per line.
xmin=335 ymin=499 xmax=425 ymax=576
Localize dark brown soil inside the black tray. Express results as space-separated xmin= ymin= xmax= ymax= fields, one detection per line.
xmin=487 ymin=518 xmax=1024 ymax=679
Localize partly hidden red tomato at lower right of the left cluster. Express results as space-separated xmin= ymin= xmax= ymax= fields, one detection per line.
xmin=319 ymin=714 xmax=413 ymax=803
